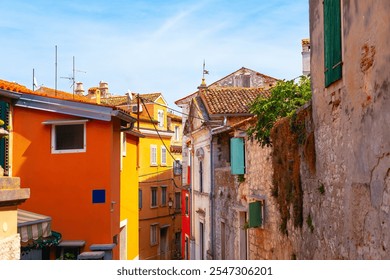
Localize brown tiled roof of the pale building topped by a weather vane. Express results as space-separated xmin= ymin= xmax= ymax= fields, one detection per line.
xmin=200 ymin=87 xmax=269 ymax=115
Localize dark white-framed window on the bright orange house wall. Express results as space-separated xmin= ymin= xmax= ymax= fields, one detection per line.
xmin=51 ymin=121 xmax=86 ymax=154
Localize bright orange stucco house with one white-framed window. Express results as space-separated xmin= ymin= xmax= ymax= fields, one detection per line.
xmin=0 ymin=81 xmax=135 ymax=259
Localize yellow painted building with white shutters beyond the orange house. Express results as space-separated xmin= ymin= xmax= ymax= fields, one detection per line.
xmin=102 ymin=90 xmax=182 ymax=259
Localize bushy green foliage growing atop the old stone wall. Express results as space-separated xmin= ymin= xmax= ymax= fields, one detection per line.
xmin=247 ymin=76 xmax=311 ymax=146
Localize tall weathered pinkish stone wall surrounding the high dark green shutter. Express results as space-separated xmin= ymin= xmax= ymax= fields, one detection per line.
xmin=289 ymin=0 xmax=390 ymax=259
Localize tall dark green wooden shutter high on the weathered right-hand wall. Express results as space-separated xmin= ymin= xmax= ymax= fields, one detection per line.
xmin=324 ymin=0 xmax=342 ymax=87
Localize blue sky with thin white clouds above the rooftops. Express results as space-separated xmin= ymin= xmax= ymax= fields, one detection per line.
xmin=0 ymin=0 xmax=309 ymax=108
